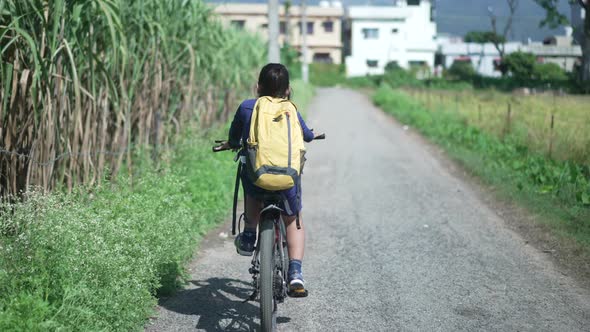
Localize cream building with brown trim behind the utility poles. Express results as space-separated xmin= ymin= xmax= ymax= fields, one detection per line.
xmin=215 ymin=4 xmax=343 ymax=64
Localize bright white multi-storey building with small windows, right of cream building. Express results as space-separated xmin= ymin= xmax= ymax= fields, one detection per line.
xmin=346 ymin=0 xmax=436 ymax=77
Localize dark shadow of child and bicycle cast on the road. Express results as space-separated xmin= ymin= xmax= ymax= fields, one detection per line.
xmin=160 ymin=278 xmax=291 ymax=331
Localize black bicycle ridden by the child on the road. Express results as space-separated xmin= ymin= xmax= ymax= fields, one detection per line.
xmin=213 ymin=134 xmax=326 ymax=331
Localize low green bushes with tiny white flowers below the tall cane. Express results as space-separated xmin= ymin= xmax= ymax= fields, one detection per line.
xmin=0 ymin=131 xmax=234 ymax=331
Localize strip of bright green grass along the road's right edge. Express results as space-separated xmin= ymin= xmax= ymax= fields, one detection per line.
xmin=373 ymin=86 xmax=590 ymax=248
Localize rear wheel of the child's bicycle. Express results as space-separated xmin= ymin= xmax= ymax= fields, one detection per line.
xmin=259 ymin=219 xmax=276 ymax=332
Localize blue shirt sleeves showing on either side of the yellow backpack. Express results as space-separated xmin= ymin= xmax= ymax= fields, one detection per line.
xmin=229 ymin=99 xmax=315 ymax=148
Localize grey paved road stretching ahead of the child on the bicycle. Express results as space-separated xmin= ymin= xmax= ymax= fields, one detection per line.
xmin=147 ymin=88 xmax=590 ymax=332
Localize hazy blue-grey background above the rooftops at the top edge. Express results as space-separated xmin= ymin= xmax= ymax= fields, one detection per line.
xmin=207 ymin=0 xmax=570 ymax=41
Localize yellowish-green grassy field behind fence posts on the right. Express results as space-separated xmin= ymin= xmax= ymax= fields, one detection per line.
xmin=406 ymin=89 xmax=590 ymax=165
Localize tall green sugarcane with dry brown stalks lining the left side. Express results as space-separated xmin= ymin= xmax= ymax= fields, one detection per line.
xmin=0 ymin=0 xmax=266 ymax=196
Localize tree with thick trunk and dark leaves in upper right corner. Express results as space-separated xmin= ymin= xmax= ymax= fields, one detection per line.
xmin=535 ymin=0 xmax=590 ymax=82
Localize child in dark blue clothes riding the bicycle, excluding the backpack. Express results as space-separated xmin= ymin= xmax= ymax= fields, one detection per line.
xmin=222 ymin=63 xmax=314 ymax=291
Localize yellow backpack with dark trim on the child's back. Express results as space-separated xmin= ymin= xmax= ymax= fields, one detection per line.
xmin=246 ymin=96 xmax=305 ymax=191
